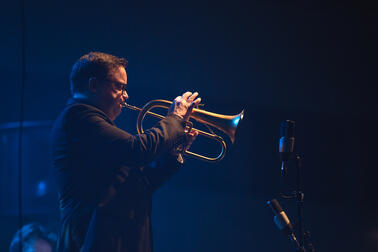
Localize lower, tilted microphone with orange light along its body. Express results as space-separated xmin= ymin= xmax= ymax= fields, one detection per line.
xmin=267 ymin=199 xmax=304 ymax=251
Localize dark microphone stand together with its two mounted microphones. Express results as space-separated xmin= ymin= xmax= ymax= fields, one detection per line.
xmin=267 ymin=120 xmax=315 ymax=252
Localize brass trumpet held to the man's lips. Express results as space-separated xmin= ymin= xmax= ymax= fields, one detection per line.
xmin=123 ymin=100 xmax=244 ymax=162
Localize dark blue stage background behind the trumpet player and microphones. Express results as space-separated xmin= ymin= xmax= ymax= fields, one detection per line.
xmin=0 ymin=0 xmax=378 ymax=252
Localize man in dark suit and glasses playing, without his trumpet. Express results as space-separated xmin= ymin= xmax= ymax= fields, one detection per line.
xmin=52 ymin=52 xmax=201 ymax=252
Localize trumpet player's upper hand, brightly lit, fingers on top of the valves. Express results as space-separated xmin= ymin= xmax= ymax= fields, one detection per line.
xmin=168 ymin=92 xmax=201 ymax=121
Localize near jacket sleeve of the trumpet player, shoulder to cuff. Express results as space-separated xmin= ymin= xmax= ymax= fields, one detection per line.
xmin=65 ymin=106 xmax=185 ymax=166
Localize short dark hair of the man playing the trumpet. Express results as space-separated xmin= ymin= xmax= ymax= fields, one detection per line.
xmin=70 ymin=52 xmax=127 ymax=94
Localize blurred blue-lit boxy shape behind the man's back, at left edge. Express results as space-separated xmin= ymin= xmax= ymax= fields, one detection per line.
xmin=0 ymin=121 xmax=58 ymax=216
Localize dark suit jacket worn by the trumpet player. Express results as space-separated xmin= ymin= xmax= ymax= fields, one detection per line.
xmin=52 ymin=99 xmax=185 ymax=252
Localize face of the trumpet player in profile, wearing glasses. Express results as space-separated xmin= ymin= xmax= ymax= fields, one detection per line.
xmin=97 ymin=67 xmax=129 ymax=121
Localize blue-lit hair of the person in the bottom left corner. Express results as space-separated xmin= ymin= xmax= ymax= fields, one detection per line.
xmin=9 ymin=222 xmax=56 ymax=252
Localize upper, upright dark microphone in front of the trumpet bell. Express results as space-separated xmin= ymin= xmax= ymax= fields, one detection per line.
xmin=278 ymin=120 xmax=295 ymax=176
